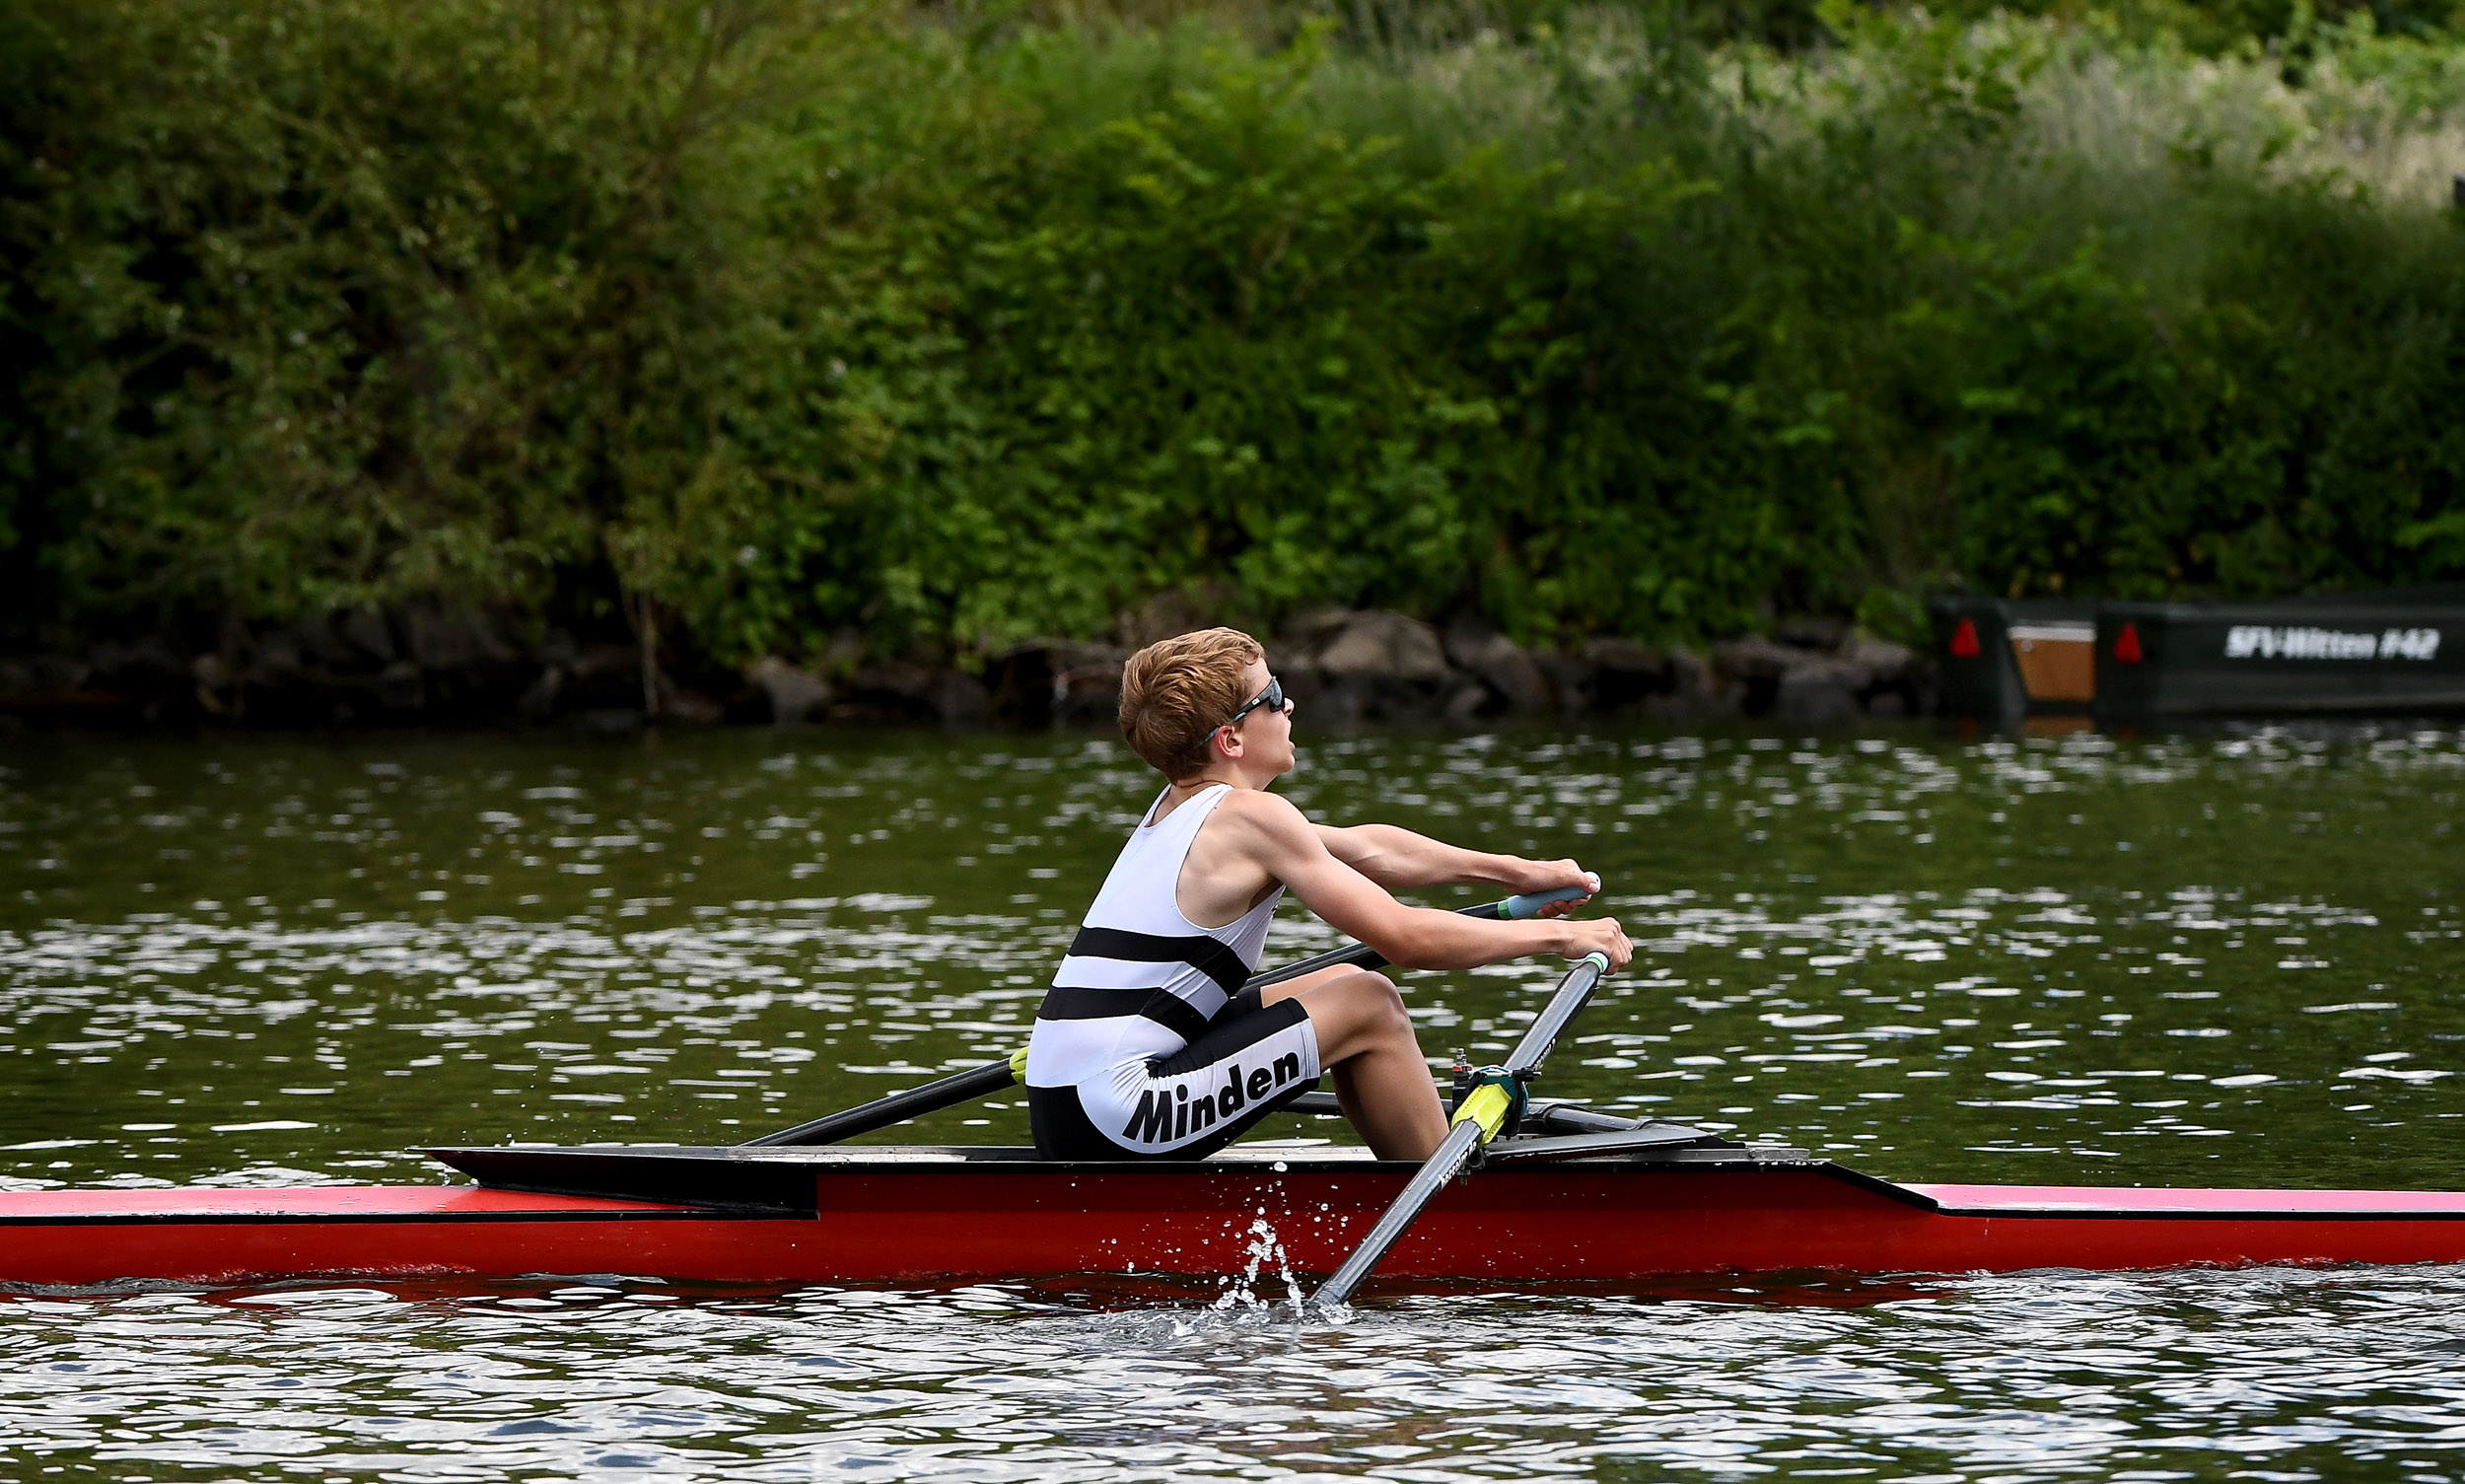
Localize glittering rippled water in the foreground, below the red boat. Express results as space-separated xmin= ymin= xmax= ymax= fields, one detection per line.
xmin=0 ymin=1267 xmax=2465 ymax=1482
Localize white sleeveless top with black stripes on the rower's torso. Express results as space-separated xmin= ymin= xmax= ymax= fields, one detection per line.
xmin=1025 ymin=784 xmax=1285 ymax=1088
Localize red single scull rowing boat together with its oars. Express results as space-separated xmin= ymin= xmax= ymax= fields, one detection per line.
xmin=0 ymin=897 xmax=2465 ymax=1302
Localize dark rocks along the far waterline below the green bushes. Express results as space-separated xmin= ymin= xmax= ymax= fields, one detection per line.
xmin=0 ymin=606 xmax=1936 ymax=730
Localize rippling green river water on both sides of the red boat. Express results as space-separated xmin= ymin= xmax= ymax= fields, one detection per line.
xmin=0 ymin=725 xmax=2465 ymax=1482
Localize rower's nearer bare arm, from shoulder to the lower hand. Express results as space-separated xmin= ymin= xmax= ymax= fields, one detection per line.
xmin=1232 ymin=794 xmax=1625 ymax=969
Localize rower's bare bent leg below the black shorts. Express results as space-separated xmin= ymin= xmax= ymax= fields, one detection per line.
xmin=1260 ymin=969 xmax=1447 ymax=1159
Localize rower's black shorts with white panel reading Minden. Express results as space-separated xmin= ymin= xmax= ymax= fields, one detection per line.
xmin=1028 ymin=989 xmax=1319 ymax=1159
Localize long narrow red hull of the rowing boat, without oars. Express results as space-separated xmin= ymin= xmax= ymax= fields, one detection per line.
xmin=0 ymin=1152 xmax=2465 ymax=1287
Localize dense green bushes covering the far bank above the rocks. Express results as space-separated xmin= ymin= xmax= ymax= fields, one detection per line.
xmin=0 ymin=0 xmax=2465 ymax=661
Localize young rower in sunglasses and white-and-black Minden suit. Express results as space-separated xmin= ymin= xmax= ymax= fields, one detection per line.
xmin=1025 ymin=629 xmax=1635 ymax=1159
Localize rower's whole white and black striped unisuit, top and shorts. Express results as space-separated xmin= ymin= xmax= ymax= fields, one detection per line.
xmin=1025 ymin=784 xmax=1319 ymax=1159
